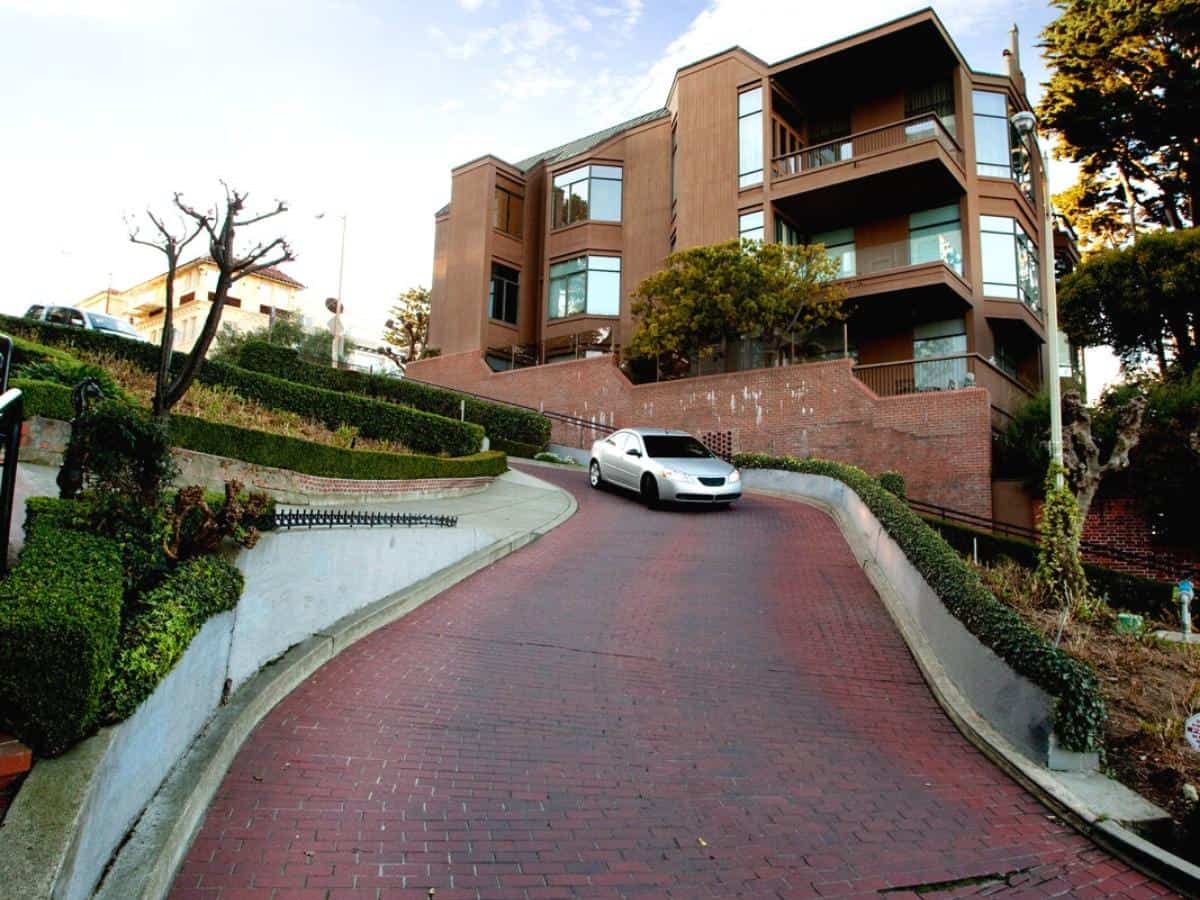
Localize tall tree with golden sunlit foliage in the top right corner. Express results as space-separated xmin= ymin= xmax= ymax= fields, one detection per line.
xmin=1039 ymin=0 xmax=1200 ymax=240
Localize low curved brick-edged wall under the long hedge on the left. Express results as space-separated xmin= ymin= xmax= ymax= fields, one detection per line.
xmin=20 ymin=415 xmax=494 ymax=504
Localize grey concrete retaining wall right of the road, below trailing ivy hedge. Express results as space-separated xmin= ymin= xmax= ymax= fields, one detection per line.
xmin=742 ymin=469 xmax=1098 ymax=770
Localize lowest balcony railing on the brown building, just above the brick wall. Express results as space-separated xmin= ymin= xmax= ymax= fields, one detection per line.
xmin=854 ymin=353 xmax=1036 ymax=416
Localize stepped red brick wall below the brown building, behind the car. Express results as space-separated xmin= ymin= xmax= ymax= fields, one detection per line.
xmin=408 ymin=353 xmax=991 ymax=517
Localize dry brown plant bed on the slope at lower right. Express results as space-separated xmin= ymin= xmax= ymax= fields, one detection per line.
xmin=978 ymin=562 xmax=1200 ymax=863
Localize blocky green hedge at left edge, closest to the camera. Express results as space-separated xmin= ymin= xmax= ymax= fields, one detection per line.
xmin=0 ymin=497 xmax=124 ymax=756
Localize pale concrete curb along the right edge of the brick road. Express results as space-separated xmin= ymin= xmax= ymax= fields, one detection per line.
xmin=746 ymin=487 xmax=1200 ymax=896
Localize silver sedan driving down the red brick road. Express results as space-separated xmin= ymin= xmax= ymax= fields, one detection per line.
xmin=588 ymin=428 xmax=742 ymax=506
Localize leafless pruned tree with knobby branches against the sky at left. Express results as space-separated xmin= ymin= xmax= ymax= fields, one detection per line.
xmin=130 ymin=181 xmax=295 ymax=416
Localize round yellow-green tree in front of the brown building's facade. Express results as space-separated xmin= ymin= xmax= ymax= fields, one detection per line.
xmin=625 ymin=241 xmax=845 ymax=374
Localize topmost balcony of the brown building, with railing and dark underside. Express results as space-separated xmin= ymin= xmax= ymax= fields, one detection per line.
xmin=770 ymin=113 xmax=966 ymax=229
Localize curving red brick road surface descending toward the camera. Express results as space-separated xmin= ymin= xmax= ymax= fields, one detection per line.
xmin=170 ymin=469 xmax=1168 ymax=900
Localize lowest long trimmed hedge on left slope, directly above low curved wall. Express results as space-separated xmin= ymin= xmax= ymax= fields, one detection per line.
xmin=19 ymin=379 xmax=508 ymax=479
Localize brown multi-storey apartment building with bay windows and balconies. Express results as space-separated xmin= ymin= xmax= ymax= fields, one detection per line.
xmin=413 ymin=10 xmax=1089 ymax=520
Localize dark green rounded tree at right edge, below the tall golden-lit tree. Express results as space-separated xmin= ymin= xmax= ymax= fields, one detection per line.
xmin=1058 ymin=228 xmax=1200 ymax=374
